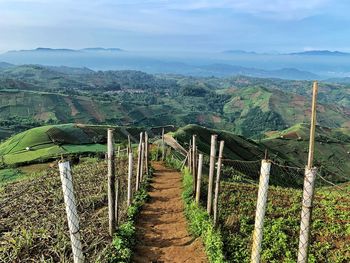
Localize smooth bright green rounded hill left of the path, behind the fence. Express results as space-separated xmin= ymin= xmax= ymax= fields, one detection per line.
xmin=0 ymin=124 xmax=144 ymax=165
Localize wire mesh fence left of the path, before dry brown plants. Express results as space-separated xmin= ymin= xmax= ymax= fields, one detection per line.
xmin=0 ymin=140 xmax=146 ymax=262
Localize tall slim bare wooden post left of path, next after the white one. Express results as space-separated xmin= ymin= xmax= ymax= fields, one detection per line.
xmin=107 ymin=129 xmax=116 ymax=236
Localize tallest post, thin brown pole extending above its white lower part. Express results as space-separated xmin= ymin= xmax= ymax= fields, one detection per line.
xmin=298 ymin=81 xmax=318 ymax=263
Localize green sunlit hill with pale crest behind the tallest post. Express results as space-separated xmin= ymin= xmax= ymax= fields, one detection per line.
xmin=262 ymin=124 xmax=350 ymax=182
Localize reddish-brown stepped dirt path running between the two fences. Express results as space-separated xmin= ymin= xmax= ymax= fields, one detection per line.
xmin=132 ymin=163 xmax=207 ymax=263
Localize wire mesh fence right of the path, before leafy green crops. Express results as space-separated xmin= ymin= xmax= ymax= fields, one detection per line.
xmin=165 ymin=134 xmax=350 ymax=263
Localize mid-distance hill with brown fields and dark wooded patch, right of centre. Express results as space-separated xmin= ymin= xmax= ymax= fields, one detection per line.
xmin=224 ymin=87 xmax=350 ymax=136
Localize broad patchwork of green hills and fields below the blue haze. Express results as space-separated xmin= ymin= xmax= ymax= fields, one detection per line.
xmin=0 ymin=65 xmax=350 ymax=139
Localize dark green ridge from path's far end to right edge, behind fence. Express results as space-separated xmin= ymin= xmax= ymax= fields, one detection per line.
xmin=173 ymin=124 xmax=350 ymax=182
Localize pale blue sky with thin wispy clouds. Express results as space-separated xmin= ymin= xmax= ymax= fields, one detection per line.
xmin=0 ymin=0 xmax=350 ymax=53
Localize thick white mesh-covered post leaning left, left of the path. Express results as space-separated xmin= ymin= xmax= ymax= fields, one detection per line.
xmin=58 ymin=162 xmax=84 ymax=263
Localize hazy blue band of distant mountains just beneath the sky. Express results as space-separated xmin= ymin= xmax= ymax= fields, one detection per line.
xmin=0 ymin=47 xmax=350 ymax=80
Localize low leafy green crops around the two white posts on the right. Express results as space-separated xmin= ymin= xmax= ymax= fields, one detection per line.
xmin=219 ymin=182 xmax=350 ymax=263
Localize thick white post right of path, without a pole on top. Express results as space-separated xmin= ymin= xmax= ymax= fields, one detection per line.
xmin=250 ymin=160 xmax=271 ymax=263
